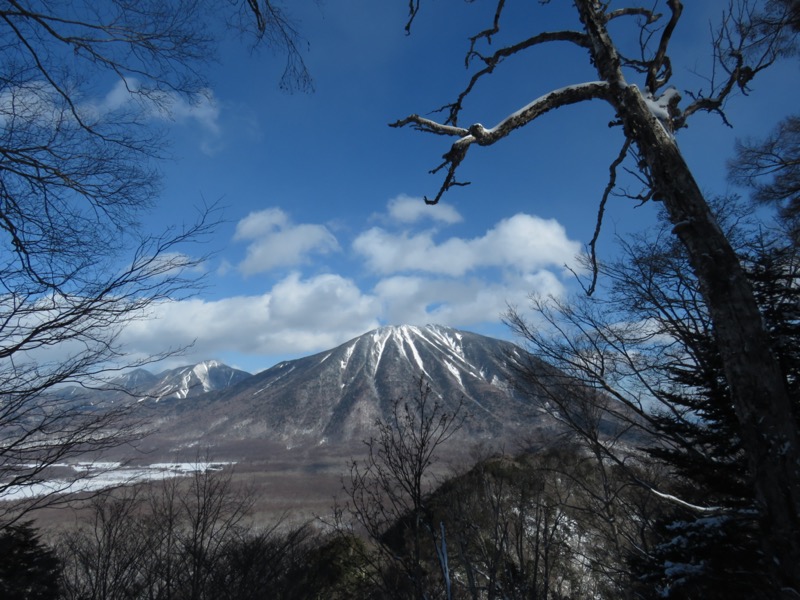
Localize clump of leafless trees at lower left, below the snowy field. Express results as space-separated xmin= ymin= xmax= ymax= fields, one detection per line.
xmin=57 ymin=462 xmax=282 ymax=600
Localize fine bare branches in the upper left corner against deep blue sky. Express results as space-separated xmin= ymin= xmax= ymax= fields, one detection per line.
xmin=0 ymin=0 xmax=309 ymax=296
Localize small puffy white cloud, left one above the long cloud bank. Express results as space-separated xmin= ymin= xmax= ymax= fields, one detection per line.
xmin=233 ymin=208 xmax=339 ymax=275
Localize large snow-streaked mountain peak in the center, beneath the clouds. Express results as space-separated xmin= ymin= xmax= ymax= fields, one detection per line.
xmin=147 ymin=325 xmax=544 ymax=445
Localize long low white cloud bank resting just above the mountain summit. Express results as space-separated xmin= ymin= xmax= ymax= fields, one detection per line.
xmin=120 ymin=271 xmax=563 ymax=368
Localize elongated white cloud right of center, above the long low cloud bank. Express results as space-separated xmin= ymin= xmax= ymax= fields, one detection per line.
xmin=353 ymin=214 xmax=580 ymax=277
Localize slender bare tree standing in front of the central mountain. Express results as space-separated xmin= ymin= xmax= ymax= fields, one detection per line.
xmin=341 ymin=379 xmax=465 ymax=600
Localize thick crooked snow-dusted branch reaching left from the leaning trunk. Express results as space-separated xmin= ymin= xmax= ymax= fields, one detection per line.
xmin=389 ymin=81 xmax=610 ymax=204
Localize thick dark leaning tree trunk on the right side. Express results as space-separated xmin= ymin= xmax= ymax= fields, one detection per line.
xmin=575 ymin=0 xmax=800 ymax=598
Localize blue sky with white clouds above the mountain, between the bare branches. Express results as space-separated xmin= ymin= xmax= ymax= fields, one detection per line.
xmin=109 ymin=0 xmax=800 ymax=372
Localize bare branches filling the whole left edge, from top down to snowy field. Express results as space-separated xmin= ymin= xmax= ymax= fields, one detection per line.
xmin=0 ymin=0 xmax=311 ymax=521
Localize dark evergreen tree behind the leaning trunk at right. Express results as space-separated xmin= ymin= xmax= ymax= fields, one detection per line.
xmin=622 ymin=223 xmax=800 ymax=599
